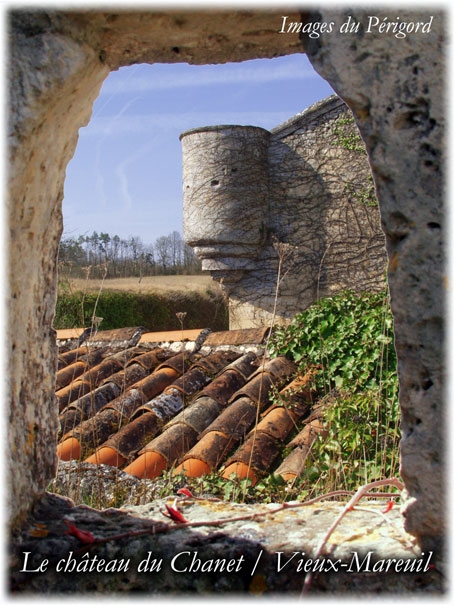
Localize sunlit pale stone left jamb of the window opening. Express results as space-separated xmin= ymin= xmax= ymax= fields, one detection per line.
xmin=7 ymin=11 xmax=108 ymax=518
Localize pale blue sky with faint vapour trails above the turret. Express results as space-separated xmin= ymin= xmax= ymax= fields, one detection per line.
xmin=63 ymin=54 xmax=332 ymax=244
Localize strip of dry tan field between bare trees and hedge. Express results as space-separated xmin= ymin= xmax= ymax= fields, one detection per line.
xmin=65 ymin=275 xmax=220 ymax=294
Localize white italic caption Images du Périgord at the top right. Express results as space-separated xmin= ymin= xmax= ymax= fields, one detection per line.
xmin=279 ymin=15 xmax=433 ymax=38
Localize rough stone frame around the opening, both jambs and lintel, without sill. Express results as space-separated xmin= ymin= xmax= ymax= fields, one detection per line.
xmin=6 ymin=7 xmax=447 ymax=548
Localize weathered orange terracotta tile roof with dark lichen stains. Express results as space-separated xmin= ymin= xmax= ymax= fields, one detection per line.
xmin=56 ymin=328 xmax=322 ymax=481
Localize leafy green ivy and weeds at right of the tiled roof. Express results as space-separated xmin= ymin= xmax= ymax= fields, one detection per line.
xmin=270 ymin=291 xmax=399 ymax=496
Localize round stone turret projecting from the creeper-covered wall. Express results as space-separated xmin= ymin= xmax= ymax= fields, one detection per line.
xmin=180 ymin=126 xmax=270 ymax=283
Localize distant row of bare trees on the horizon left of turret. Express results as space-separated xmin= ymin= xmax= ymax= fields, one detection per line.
xmin=58 ymin=231 xmax=201 ymax=279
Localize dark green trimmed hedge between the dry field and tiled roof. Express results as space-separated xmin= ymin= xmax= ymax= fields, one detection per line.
xmin=54 ymin=290 xmax=229 ymax=331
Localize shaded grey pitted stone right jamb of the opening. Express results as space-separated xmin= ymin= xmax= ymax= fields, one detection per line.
xmin=304 ymin=10 xmax=447 ymax=545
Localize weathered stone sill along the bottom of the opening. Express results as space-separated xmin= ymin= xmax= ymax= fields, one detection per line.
xmin=11 ymin=494 xmax=445 ymax=597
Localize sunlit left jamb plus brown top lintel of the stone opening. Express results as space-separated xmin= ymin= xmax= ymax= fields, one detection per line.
xmin=7 ymin=9 xmax=301 ymax=526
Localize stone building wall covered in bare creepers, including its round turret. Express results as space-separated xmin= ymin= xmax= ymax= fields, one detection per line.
xmin=181 ymin=96 xmax=386 ymax=329
